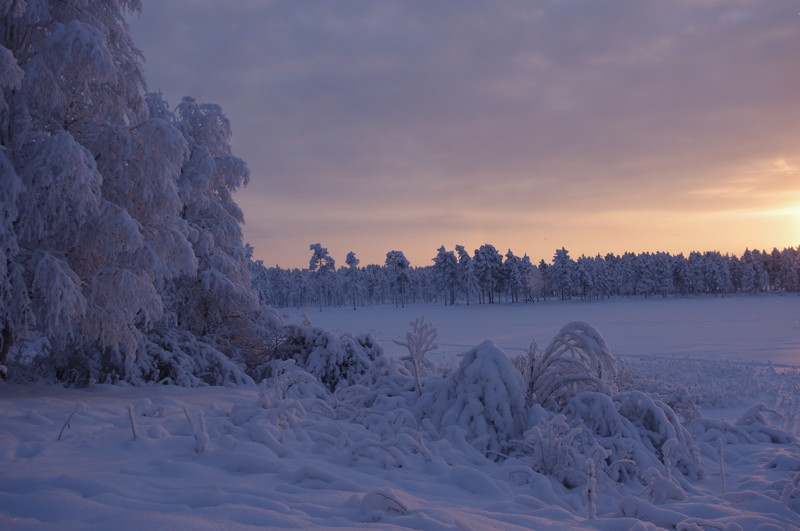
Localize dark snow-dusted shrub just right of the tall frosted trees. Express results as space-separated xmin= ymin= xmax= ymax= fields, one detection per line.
xmin=276 ymin=325 xmax=383 ymax=391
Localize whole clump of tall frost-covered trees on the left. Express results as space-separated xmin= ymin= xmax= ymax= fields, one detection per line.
xmin=0 ymin=0 xmax=271 ymax=384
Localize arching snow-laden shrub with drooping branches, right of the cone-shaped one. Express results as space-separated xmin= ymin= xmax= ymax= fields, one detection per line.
xmin=527 ymin=321 xmax=617 ymax=407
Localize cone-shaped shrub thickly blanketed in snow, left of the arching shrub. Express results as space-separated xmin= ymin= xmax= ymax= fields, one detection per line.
xmin=417 ymin=340 xmax=526 ymax=454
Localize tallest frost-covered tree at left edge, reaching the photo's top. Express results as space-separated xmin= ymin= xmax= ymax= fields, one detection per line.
xmin=0 ymin=1 xmax=179 ymax=381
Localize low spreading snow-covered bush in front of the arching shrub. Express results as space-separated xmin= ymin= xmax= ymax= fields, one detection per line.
xmin=512 ymin=391 xmax=702 ymax=492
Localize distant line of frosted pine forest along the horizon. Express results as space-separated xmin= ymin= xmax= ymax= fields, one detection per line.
xmin=250 ymin=244 xmax=800 ymax=308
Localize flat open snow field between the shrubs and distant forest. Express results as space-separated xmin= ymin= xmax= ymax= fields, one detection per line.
xmin=292 ymin=294 xmax=800 ymax=367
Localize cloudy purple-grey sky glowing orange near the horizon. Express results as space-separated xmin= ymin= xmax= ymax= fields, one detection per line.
xmin=130 ymin=0 xmax=800 ymax=267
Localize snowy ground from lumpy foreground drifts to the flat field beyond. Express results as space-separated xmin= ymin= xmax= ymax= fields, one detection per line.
xmin=0 ymin=295 xmax=800 ymax=531
